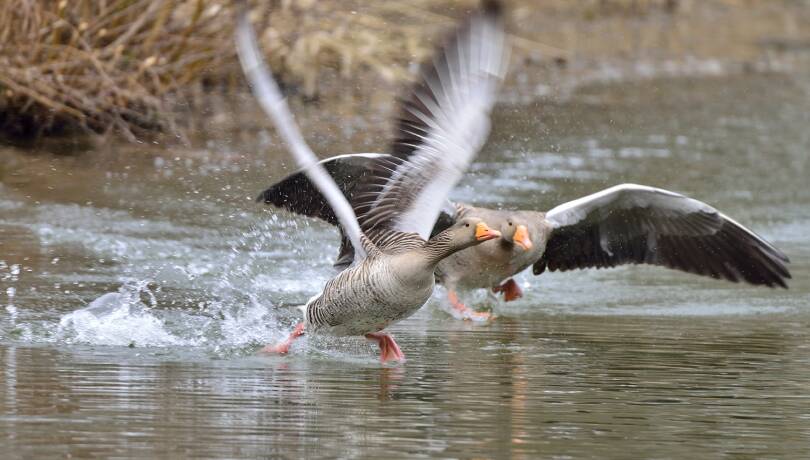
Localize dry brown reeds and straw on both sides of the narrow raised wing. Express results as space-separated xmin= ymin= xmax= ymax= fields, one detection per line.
xmin=0 ymin=0 xmax=469 ymax=139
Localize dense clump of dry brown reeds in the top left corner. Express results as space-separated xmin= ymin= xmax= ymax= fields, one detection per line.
xmin=0 ymin=0 xmax=225 ymax=138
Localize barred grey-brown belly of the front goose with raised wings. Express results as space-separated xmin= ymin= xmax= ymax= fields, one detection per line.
xmin=306 ymin=263 xmax=433 ymax=336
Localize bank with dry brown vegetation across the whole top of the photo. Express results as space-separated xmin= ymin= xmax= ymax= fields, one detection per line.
xmin=0 ymin=0 xmax=810 ymax=144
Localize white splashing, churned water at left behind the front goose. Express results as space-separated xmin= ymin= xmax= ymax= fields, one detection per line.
xmin=7 ymin=201 xmax=336 ymax=356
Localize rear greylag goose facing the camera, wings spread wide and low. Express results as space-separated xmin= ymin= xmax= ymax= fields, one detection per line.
xmin=257 ymin=153 xmax=791 ymax=320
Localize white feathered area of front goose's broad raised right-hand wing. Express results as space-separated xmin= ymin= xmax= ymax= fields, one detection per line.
xmin=380 ymin=8 xmax=509 ymax=239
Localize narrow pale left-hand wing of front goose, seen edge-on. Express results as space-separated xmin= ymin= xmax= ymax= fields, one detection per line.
xmin=235 ymin=5 xmax=366 ymax=260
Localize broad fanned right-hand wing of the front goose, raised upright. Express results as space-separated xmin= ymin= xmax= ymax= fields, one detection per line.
xmin=353 ymin=1 xmax=508 ymax=239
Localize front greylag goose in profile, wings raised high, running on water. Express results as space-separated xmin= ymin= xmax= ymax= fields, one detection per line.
xmin=236 ymin=2 xmax=507 ymax=362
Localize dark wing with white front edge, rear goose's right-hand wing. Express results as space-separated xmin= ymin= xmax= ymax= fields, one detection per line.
xmin=534 ymin=184 xmax=790 ymax=288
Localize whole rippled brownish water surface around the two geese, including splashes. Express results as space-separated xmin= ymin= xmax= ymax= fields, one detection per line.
xmin=0 ymin=75 xmax=810 ymax=458
